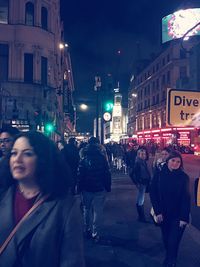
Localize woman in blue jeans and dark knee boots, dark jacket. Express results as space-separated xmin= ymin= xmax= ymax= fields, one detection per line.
xmin=132 ymin=148 xmax=151 ymax=222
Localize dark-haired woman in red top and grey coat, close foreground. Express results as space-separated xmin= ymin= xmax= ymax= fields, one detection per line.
xmin=0 ymin=132 xmax=85 ymax=267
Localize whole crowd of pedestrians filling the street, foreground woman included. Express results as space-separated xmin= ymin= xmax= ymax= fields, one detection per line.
xmin=0 ymin=127 xmax=195 ymax=267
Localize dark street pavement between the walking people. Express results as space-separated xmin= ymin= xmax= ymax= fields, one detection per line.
xmin=85 ymin=173 xmax=200 ymax=267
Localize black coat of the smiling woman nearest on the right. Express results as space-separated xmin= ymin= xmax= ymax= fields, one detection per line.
xmin=150 ymin=165 xmax=190 ymax=222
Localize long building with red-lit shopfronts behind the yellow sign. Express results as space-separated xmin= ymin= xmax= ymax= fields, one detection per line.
xmin=128 ymin=38 xmax=198 ymax=145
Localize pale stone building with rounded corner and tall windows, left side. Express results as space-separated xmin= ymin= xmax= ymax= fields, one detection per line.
xmin=0 ymin=0 xmax=74 ymax=140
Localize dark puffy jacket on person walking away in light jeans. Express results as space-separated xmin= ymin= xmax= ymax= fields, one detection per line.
xmin=78 ymin=145 xmax=111 ymax=192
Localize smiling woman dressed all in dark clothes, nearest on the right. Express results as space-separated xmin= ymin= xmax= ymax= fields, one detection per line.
xmin=150 ymin=151 xmax=190 ymax=267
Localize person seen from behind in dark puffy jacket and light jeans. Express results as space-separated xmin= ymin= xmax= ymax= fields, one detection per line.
xmin=78 ymin=137 xmax=111 ymax=242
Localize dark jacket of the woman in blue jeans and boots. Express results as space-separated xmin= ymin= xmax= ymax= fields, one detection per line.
xmin=134 ymin=157 xmax=151 ymax=185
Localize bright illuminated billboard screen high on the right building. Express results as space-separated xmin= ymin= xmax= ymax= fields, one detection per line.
xmin=162 ymin=8 xmax=200 ymax=43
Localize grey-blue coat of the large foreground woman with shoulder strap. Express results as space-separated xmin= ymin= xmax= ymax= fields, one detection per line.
xmin=0 ymin=187 xmax=85 ymax=267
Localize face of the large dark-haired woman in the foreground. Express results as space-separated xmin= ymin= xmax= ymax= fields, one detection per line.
xmin=10 ymin=137 xmax=37 ymax=181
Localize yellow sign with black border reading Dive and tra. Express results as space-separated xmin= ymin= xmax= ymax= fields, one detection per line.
xmin=166 ymin=89 xmax=200 ymax=127
